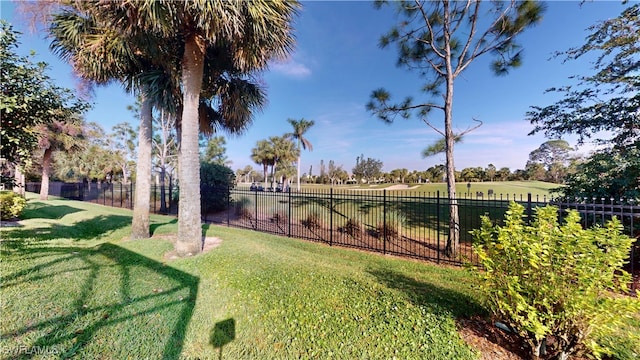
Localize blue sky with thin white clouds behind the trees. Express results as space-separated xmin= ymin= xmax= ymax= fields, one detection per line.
xmin=0 ymin=1 xmax=624 ymax=174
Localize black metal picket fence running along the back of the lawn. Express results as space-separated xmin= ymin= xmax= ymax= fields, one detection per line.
xmin=22 ymin=183 xmax=640 ymax=290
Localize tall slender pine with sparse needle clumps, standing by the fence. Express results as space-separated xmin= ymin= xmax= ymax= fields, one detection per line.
xmin=367 ymin=0 xmax=544 ymax=256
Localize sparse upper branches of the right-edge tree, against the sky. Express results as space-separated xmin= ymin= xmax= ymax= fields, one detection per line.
xmin=527 ymin=4 xmax=640 ymax=147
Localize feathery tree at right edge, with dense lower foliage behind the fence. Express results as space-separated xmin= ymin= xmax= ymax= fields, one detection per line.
xmin=527 ymin=4 xmax=640 ymax=199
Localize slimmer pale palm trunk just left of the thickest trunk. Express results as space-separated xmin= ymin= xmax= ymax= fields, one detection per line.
xmin=131 ymin=89 xmax=153 ymax=239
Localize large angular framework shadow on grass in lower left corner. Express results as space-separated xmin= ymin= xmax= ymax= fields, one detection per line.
xmin=0 ymin=242 xmax=199 ymax=359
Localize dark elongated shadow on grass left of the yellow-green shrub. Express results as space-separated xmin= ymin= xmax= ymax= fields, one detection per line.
xmin=368 ymin=269 xmax=486 ymax=318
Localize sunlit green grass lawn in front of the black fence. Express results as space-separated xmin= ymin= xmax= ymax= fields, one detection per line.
xmin=0 ymin=198 xmax=484 ymax=359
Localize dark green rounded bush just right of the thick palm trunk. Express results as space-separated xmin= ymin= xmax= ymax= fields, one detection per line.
xmin=200 ymin=162 xmax=235 ymax=214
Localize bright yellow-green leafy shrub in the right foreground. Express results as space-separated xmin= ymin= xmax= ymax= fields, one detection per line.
xmin=472 ymin=203 xmax=640 ymax=359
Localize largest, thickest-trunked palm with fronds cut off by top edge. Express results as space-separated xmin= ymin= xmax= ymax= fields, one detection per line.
xmin=80 ymin=0 xmax=298 ymax=255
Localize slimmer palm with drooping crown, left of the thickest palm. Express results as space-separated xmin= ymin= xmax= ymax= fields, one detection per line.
xmin=49 ymin=6 xmax=170 ymax=239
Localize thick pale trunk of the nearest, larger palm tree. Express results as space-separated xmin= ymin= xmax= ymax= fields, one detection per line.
xmin=176 ymin=34 xmax=205 ymax=256
